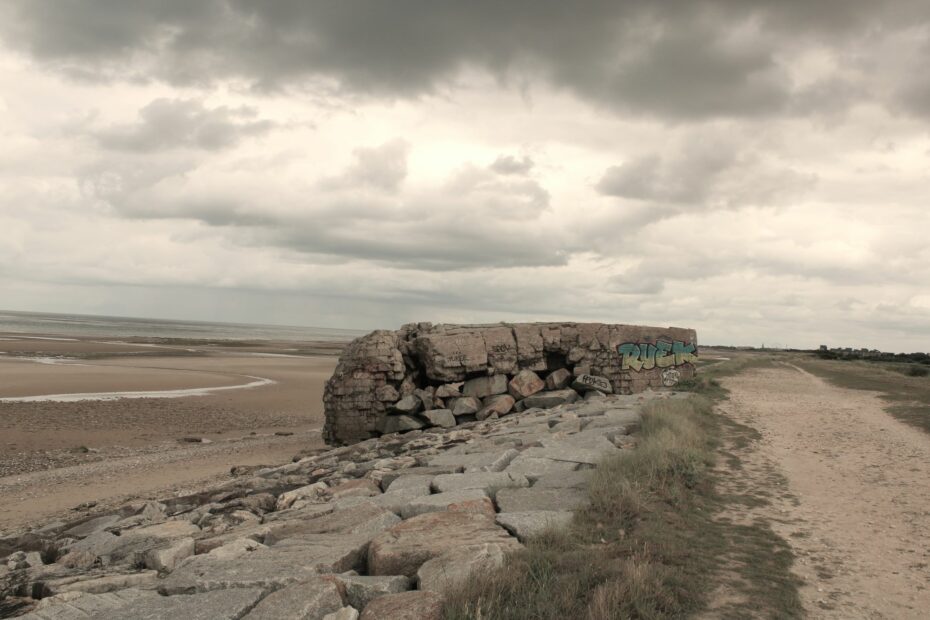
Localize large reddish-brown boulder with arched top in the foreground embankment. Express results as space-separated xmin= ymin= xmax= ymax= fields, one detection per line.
xmin=368 ymin=512 xmax=519 ymax=576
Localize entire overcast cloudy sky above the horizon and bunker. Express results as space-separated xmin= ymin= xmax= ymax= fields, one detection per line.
xmin=0 ymin=0 xmax=930 ymax=351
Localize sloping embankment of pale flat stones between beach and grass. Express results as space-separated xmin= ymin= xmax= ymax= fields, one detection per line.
xmin=0 ymin=390 xmax=681 ymax=620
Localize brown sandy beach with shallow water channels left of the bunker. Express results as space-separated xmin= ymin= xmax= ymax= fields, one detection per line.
xmin=0 ymin=333 xmax=341 ymax=532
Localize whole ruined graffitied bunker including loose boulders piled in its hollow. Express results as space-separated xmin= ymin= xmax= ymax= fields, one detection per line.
xmin=323 ymin=323 xmax=697 ymax=445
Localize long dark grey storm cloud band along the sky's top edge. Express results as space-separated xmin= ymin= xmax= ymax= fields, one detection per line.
xmin=7 ymin=0 xmax=928 ymax=118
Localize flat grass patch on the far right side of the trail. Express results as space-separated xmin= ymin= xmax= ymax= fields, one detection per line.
xmin=792 ymin=356 xmax=930 ymax=433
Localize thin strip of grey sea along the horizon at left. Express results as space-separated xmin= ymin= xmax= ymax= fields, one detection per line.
xmin=0 ymin=310 xmax=366 ymax=342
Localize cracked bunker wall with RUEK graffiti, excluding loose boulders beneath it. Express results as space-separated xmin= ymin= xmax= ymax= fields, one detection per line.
xmin=323 ymin=323 xmax=698 ymax=444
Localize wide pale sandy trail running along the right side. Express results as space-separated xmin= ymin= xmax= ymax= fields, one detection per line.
xmin=721 ymin=365 xmax=930 ymax=619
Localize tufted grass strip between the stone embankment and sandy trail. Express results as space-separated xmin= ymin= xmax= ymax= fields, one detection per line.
xmin=445 ymin=392 xmax=800 ymax=620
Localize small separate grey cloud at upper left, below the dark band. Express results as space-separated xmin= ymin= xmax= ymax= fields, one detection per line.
xmin=94 ymin=99 xmax=273 ymax=153
